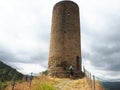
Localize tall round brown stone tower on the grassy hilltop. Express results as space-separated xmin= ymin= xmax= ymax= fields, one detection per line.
xmin=48 ymin=0 xmax=81 ymax=77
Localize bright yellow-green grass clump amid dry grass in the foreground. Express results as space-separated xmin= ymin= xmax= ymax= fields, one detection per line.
xmin=34 ymin=82 xmax=56 ymax=90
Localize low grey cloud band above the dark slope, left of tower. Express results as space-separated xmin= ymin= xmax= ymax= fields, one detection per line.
xmin=0 ymin=44 xmax=48 ymax=69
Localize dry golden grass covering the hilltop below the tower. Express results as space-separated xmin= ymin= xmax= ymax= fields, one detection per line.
xmin=6 ymin=75 xmax=104 ymax=90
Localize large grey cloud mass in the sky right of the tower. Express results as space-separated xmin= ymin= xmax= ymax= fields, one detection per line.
xmin=82 ymin=9 xmax=120 ymax=73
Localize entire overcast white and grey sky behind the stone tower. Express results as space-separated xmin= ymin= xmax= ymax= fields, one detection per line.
xmin=0 ymin=0 xmax=120 ymax=80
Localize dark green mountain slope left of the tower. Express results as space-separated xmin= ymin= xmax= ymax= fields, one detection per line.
xmin=0 ymin=61 xmax=23 ymax=81
